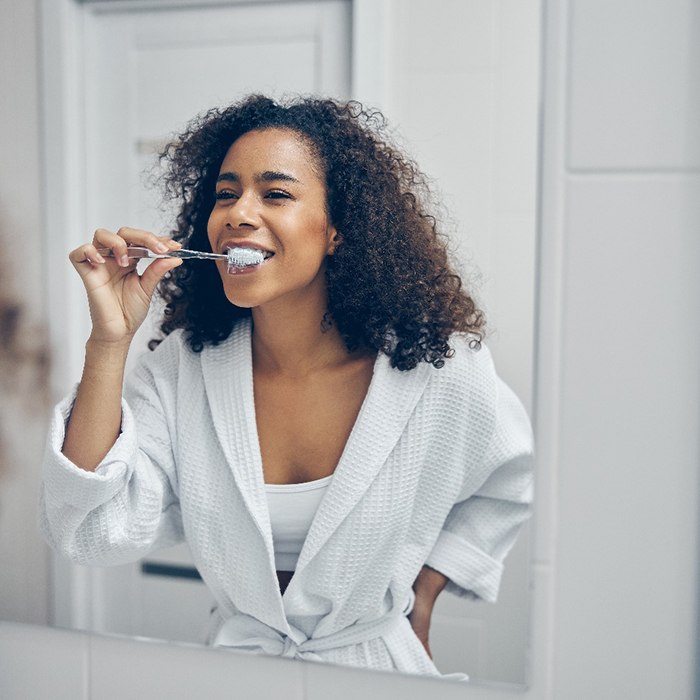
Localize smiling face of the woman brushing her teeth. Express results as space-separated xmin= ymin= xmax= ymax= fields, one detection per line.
xmin=207 ymin=128 xmax=336 ymax=308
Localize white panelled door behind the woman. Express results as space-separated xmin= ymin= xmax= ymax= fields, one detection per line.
xmin=78 ymin=0 xmax=351 ymax=642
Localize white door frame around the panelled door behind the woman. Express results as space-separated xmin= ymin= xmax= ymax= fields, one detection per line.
xmin=38 ymin=0 xmax=391 ymax=631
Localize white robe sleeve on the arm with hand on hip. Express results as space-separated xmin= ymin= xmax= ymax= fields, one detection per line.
xmin=426 ymin=372 xmax=533 ymax=602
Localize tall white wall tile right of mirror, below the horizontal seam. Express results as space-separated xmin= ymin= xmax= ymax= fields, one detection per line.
xmin=554 ymin=176 xmax=700 ymax=700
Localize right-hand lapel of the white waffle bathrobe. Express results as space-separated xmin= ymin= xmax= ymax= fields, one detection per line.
xmin=288 ymin=354 xmax=431 ymax=590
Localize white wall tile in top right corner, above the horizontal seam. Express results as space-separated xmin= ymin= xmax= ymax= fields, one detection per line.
xmin=569 ymin=0 xmax=700 ymax=169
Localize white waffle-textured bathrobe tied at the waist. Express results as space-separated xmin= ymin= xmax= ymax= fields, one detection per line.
xmin=42 ymin=322 xmax=532 ymax=673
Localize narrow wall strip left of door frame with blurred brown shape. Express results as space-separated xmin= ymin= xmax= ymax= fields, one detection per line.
xmin=0 ymin=0 xmax=51 ymax=623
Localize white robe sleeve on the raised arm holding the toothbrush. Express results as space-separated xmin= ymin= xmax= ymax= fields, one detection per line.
xmin=40 ymin=353 xmax=183 ymax=566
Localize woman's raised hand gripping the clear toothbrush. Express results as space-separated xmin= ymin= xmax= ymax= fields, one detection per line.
xmin=68 ymin=228 xmax=182 ymax=345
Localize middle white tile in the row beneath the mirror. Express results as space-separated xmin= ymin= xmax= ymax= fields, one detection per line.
xmin=90 ymin=636 xmax=303 ymax=700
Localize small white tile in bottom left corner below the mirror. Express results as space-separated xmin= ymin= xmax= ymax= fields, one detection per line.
xmin=0 ymin=622 xmax=88 ymax=700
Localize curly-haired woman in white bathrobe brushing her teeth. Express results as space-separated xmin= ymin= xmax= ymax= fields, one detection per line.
xmin=43 ymin=96 xmax=531 ymax=674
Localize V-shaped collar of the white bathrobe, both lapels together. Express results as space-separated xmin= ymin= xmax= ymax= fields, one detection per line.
xmin=201 ymin=320 xmax=431 ymax=608
